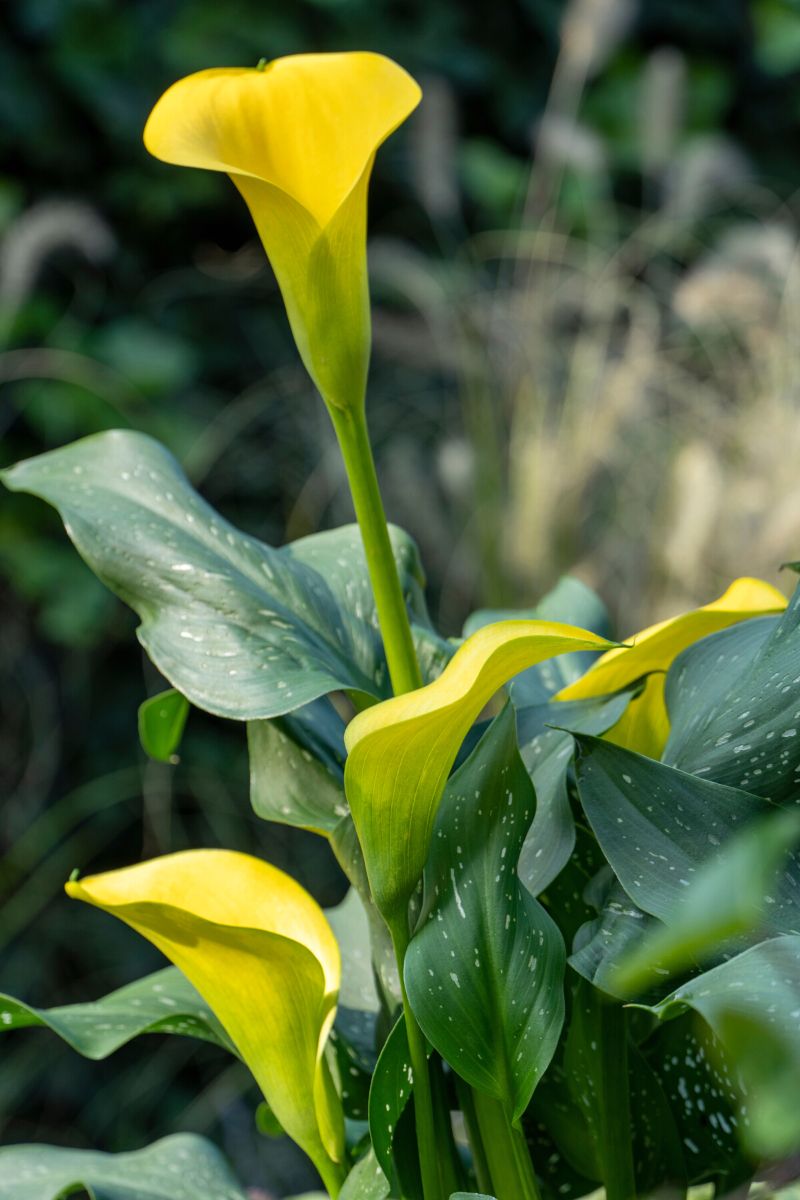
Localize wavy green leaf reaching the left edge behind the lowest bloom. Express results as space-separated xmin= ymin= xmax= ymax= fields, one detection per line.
xmin=0 ymin=967 xmax=236 ymax=1058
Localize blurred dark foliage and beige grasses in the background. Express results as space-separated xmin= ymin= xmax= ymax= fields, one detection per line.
xmin=0 ymin=0 xmax=800 ymax=1194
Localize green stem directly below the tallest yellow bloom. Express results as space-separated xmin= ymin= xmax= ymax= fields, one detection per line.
xmin=330 ymin=408 xmax=422 ymax=696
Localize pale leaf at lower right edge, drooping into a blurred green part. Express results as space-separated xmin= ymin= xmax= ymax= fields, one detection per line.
xmin=652 ymin=934 xmax=800 ymax=1158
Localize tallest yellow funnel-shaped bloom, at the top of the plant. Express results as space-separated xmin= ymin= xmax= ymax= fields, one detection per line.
xmin=144 ymin=53 xmax=421 ymax=409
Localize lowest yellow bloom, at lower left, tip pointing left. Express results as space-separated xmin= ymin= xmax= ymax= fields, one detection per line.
xmin=66 ymin=850 xmax=343 ymax=1190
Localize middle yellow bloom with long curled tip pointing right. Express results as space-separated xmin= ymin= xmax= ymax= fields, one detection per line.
xmin=344 ymin=620 xmax=612 ymax=925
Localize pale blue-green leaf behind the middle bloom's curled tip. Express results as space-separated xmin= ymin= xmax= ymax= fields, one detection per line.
xmin=464 ymin=575 xmax=610 ymax=708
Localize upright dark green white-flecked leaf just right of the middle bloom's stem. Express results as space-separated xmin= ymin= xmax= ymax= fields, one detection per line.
xmin=404 ymin=706 xmax=565 ymax=1121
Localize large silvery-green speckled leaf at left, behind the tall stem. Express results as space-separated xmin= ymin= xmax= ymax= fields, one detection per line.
xmin=1 ymin=430 xmax=449 ymax=720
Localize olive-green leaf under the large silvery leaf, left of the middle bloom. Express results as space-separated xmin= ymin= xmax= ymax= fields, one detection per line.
xmin=247 ymin=697 xmax=348 ymax=836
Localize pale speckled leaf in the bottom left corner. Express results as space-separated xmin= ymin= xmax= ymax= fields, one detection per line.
xmin=0 ymin=1133 xmax=246 ymax=1200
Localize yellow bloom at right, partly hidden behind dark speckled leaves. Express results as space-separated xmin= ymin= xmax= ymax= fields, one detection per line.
xmin=555 ymin=578 xmax=787 ymax=758
